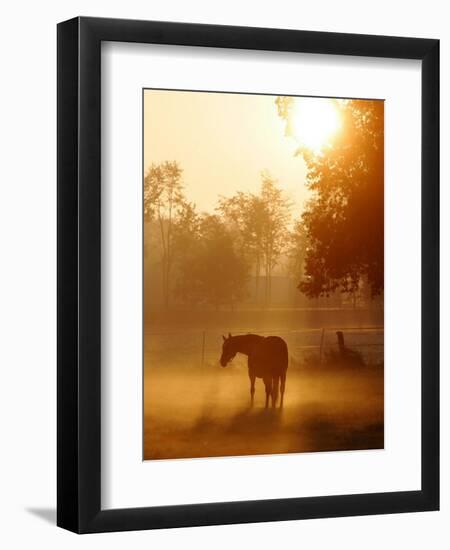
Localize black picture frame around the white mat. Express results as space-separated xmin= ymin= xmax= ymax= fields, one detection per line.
xmin=57 ymin=17 xmax=439 ymax=533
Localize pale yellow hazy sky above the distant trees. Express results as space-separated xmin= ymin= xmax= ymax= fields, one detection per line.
xmin=144 ymin=90 xmax=308 ymax=217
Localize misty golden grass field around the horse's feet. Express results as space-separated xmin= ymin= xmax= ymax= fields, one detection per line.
xmin=143 ymin=310 xmax=384 ymax=459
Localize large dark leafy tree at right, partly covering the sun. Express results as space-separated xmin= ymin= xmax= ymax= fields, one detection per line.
xmin=276 ymin=97 xmax=384 ymax=297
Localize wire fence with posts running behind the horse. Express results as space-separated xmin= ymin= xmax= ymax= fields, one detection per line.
xmin=145 ymin=326 xmax=384 ymax=366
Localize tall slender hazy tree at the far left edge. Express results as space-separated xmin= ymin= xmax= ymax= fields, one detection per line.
xmin=144 ymin=161 xmax=186 ymax=308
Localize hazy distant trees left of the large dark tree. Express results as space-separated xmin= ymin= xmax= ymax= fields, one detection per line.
xmin=144 ymin=161 xmax=295 ymax=308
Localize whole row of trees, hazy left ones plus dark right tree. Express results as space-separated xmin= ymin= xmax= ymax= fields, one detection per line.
xmin=144 ymin=97 xmax=384 ymax=308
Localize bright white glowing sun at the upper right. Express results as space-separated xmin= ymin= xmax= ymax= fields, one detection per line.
xmin=291 ymin=98 xmax=341 ymax=152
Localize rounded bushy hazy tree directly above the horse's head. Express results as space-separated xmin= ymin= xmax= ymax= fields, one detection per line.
xmin=176 ymin=214 xmax=248 ymax=309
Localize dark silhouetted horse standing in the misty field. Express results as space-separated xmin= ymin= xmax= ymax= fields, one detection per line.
xmin=220 ymin=334 xmax=289 ymax=408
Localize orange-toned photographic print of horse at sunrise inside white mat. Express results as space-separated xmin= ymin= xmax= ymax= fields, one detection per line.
xmin=143 ymin=89 xmax=384 ymax=460
